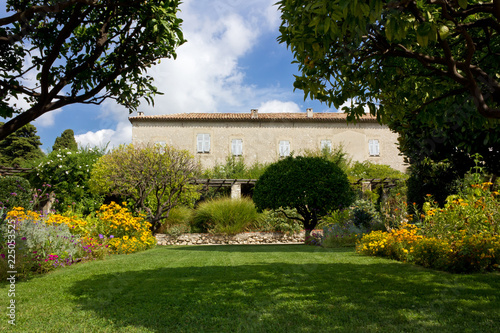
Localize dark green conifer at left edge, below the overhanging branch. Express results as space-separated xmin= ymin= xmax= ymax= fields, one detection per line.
xmin=0 ymin=122 xmax=44 ymax=166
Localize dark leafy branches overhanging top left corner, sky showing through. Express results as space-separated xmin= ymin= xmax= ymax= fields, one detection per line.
xmin=0 ymin=0 xmax=185 ymax=139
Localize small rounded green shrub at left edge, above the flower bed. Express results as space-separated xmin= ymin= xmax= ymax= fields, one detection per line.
xmin=0 ymin=176 xmax=32 ymax=209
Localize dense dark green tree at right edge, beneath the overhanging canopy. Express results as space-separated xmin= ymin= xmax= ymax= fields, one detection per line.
xmin=387 ymin=93 xmax=500 ymax=177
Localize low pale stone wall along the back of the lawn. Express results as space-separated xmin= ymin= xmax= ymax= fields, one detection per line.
xmin=155 ymin=230 xmax=322 ymax=245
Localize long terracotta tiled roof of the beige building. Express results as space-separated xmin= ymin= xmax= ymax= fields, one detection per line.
xmin=129 ymin=112 xmax=377 ymax=122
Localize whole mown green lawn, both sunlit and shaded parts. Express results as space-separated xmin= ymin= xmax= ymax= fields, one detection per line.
xmin=0 ymin=245 xmax=500 ymax=333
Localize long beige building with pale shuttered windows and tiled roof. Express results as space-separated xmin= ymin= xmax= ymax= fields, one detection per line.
xmin=129 ymin=109 xmax=406 ymax=171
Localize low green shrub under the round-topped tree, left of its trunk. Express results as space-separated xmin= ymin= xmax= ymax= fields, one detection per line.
xmin=251 ymin=209 xmax=302 ymax=234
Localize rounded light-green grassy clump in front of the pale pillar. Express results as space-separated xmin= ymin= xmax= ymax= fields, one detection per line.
xmin=193 ymin=198 xmax=259 ymax=234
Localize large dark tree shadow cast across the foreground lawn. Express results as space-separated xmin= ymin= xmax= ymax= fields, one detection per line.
xmin=69 ymin=246 xmax=500 ymax=332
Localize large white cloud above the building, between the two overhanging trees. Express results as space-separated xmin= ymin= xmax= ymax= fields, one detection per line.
xmin=137 ymin=0 xmax=286 ymax=114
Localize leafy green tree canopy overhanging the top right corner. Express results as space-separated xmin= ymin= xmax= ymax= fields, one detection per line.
xmin=278 ymin=0 xmax=500 ymax=119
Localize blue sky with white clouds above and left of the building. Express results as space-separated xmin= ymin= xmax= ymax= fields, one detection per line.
xmin=0 ymin=0 xmax=344 ymax=151
